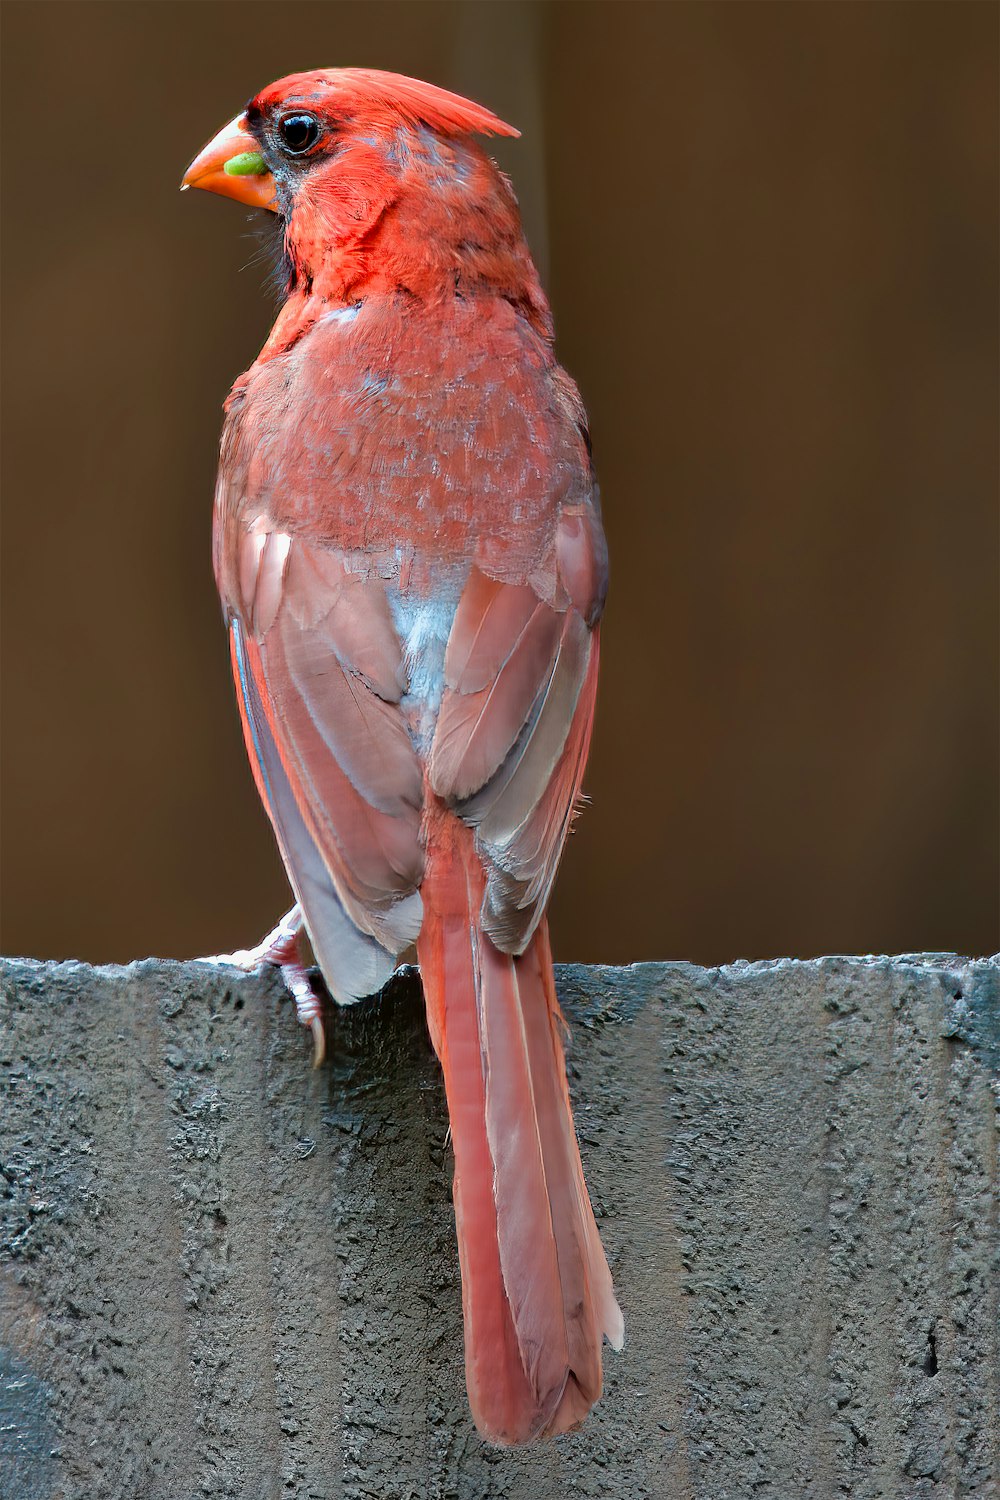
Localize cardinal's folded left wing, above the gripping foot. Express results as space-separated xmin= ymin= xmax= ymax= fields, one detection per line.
xmin=229 ymin=519 xmax=423 ymax=1001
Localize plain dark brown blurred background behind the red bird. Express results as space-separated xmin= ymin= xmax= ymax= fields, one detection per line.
xmin=1 ymin=0 xmax=999 ymax=963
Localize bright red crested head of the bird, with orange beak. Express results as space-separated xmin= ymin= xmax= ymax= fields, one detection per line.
xmin=181 ymin=68 xmax=544 ymax=319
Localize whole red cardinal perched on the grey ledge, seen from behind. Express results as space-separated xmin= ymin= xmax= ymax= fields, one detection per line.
xmin=184 ymin=68 xmax=624 ymax=1443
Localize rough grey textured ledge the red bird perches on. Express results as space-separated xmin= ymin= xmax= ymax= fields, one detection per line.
xmin=0 ymin=956 xmax=1000 ymax=1500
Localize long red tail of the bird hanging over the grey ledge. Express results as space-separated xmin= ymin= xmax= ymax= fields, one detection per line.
xmin=417 ymin=815 xmax=624 ymax=1443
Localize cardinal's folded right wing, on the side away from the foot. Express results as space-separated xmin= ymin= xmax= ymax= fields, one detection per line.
xmin=429 ymin=504 xmax=607 ymax=953
